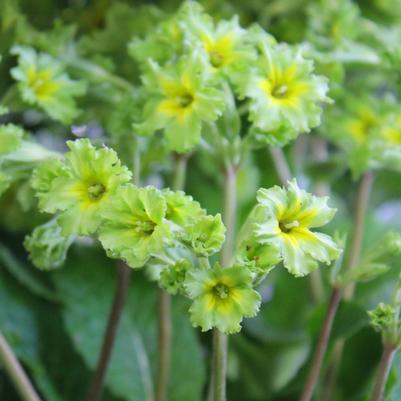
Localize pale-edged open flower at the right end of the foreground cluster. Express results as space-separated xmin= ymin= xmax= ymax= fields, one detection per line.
xmin=255 ymin=180 xmax=340 ymax=276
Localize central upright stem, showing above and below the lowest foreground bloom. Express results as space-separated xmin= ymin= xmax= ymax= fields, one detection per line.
xmin=209 ymin=165 xmax=237 ymax=401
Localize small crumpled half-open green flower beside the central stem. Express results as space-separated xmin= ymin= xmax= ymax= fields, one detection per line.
xmin=185 ymin=214 xmax=226 ymax=256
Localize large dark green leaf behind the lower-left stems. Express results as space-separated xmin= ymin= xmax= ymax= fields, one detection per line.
xmin=52 ymin=245 xmax=204 ymax=401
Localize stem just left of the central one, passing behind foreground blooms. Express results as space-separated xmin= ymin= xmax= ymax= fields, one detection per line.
xmin=155 ymin=153 xmax=188 ymax=401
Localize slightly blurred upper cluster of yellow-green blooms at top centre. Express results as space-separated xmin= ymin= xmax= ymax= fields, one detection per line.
xmin=129 ymin=2 xmax=329 ymax=153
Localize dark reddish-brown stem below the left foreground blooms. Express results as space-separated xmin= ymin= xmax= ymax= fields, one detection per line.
xmin=86 ymin=261 xmax=130 ymax=401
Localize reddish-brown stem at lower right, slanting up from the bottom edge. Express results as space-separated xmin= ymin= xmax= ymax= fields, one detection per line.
xmin=299 ymin=288 xmax=341 ymax=401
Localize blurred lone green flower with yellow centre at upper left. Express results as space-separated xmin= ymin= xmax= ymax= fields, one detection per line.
xmin=11 ymin=46 xmax=85 ymax=124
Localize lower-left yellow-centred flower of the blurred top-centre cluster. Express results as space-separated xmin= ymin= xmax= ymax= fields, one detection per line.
xmin=135 ymin=54 xmax=224 ymax=153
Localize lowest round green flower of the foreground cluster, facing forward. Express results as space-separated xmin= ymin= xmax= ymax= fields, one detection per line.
xmin=185 ymin=266 xmax=260 ymax=334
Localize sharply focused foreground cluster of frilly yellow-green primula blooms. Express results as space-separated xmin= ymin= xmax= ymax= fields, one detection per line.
xmin=25 ymin=139 xmax=340 ymax=333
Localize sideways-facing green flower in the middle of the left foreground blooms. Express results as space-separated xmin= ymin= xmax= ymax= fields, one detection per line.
xmin=99 ymin=184 xmax=171 ymax=268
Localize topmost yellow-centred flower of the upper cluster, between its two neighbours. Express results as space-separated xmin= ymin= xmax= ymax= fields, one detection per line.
xmin=181 ymin=6 xmax=256 ymax=76
